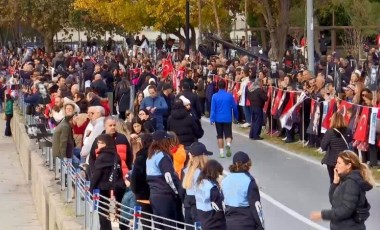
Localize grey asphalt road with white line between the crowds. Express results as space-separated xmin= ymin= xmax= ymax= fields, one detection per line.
xmin=200 ymin=118 xmax=380 ymax=230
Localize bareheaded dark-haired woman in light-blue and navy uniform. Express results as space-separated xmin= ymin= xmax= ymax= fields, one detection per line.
xmin=194 ymin=160 xmax=226 ymax=230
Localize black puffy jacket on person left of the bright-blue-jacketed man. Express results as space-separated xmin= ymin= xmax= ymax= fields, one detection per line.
xmin=168 ymin=106 xmax=201 ymax=146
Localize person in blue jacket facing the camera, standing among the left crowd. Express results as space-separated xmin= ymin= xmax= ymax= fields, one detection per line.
xmin=140 ymin=85 xmax=168 ymax=130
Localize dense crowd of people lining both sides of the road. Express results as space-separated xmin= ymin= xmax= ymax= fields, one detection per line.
xmin=0 ymin=33 xmax=380 ymax=230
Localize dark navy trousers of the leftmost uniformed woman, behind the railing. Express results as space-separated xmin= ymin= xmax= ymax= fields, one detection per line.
xmin=149 ymin=194 xmax=177 ymax=230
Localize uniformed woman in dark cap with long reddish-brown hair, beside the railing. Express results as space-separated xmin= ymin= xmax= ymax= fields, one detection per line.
xmin=146 ymin=130 xmax=182 ymax=229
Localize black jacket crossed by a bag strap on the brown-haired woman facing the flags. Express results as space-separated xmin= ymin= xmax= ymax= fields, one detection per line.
xmin=321 ymin=129 xmax=352 ymax=166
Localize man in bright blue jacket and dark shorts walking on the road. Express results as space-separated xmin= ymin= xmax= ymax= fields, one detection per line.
xmin=210 ymin=80 xmax=238 ymax=158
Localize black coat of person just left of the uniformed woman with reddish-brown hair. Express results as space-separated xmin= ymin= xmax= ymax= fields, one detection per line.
xmin=130 ymin=147 xmax=150 ymax=200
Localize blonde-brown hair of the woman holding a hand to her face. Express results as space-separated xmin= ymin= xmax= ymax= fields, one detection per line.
xmin=338 ymin=150 xmax=376 ymax=186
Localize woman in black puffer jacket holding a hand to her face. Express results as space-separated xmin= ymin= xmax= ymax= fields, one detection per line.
xmin=310 ymin=150 xmax=375 ymax=230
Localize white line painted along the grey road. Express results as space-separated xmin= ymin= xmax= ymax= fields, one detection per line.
xmin=223 ymin=170 xmax=328 ymax=230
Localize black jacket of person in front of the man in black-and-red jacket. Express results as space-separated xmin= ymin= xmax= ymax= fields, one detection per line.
xmin=90 ymin=147 xmax=125 ymax=192
